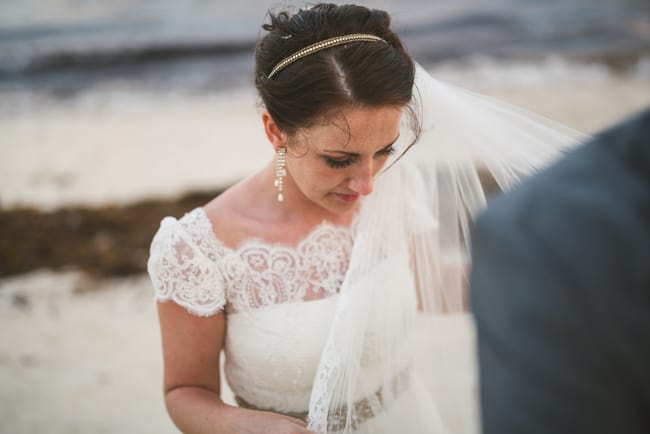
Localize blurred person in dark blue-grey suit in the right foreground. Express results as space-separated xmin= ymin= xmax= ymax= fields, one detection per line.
xmin=471 ymin=110 xmax=650 ymax=434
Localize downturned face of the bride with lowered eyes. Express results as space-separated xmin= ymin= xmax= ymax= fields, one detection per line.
xmin=285 ymin=107 xmax=402 ymax=214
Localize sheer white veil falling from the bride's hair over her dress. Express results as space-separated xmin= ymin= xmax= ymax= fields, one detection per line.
xmin=308 ymin=65 xmax=586 ymax=434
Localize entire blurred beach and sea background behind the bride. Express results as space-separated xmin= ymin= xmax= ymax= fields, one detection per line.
xmin=0 ymin=0 xmax=650 ymax=434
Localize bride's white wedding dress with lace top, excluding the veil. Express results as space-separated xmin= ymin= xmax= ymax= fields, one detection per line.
xmin=148 ymin=208 xmax=476 ymax=434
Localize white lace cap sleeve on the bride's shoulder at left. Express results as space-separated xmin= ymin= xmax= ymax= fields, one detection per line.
xmin=147 ymin=212 xmax=226 ymax=316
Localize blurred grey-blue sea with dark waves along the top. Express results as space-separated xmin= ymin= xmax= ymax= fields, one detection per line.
xmin=0 ymin=0 xmax=650 ymax=101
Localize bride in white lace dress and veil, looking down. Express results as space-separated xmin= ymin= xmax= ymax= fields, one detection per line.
xmin=148 ymin=4 xmax=580 ymax=433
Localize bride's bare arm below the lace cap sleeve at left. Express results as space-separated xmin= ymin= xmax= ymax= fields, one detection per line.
xmin=158 ymin=302 xmax=309 ymax=434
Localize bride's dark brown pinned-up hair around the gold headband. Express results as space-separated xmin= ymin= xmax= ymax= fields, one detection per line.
xmin=255 ymin=3 xmax=419 ymax=142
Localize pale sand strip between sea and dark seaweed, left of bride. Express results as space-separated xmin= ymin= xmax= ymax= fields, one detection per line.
xmin=0 ymin=91 xmax=272 ymax=209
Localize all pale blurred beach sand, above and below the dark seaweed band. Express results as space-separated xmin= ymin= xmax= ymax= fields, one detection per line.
xmin=0 ymin=60 xmax=650 ymax=434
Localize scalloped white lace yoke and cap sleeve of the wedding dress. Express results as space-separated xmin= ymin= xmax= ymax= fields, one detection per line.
xmin=148 ymin=207 xmax=354 ymax=316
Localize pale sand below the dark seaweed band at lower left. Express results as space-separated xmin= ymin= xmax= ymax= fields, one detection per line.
xmin=0 ymin=272 xmax=176 ymax=434
